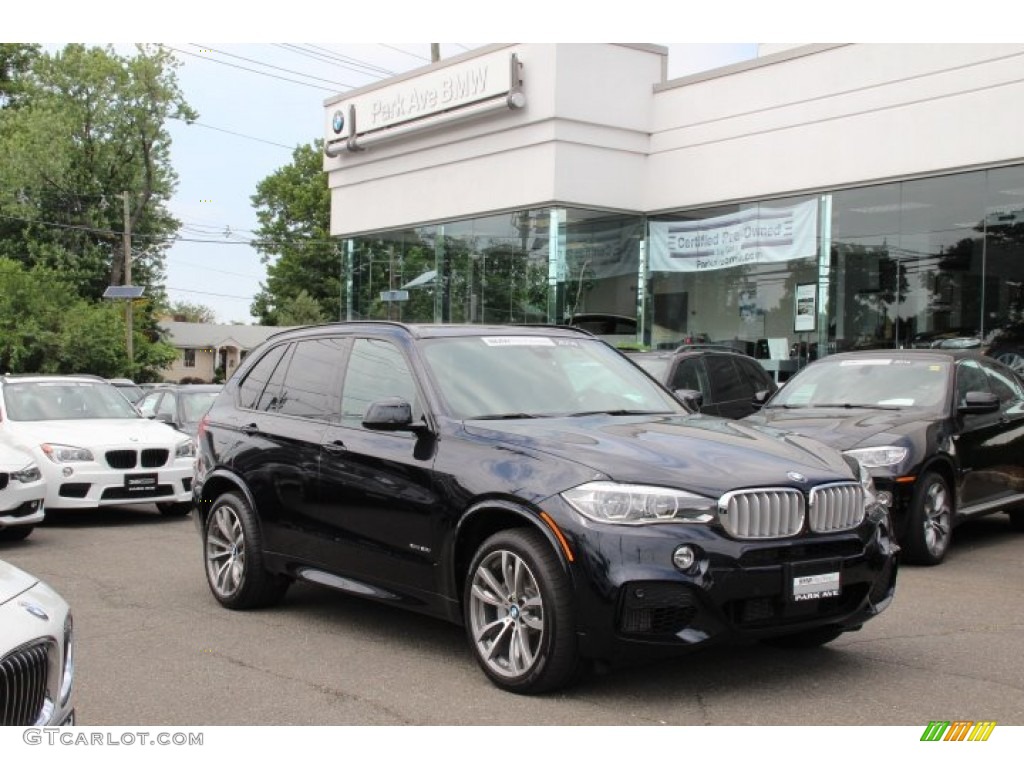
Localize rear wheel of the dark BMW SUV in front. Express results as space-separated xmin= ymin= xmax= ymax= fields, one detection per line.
xmin=203 ymin=493 xmax=291 ymax=610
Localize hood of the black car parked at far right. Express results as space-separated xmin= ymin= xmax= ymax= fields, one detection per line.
xmin=743 ymin=408 xmax=936 ymax=451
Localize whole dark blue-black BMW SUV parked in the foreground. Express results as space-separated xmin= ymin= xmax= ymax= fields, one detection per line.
xmin=195 ymin=323 xmax=897 ymax=693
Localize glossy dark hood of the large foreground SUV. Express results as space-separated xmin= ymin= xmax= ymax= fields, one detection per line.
xmin=465 ymin=415 xmax=857 ymax=498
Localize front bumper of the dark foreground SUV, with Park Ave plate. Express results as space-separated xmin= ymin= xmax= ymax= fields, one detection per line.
xmin=560 ymin=499 xmax=899 ymax=660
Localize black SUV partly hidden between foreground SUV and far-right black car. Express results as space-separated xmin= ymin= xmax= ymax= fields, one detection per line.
xmin=627 ymin=344 xmax=778 ymax=419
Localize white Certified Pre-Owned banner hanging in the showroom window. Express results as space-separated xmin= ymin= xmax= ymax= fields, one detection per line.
xmin=650 ymin=200 xmax=818 ymax=272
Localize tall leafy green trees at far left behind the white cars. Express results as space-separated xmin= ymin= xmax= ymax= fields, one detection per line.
xmin=0 ymin=44 xmax=197 ymax=376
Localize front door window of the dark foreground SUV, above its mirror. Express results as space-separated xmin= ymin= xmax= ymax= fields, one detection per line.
xmin=341 ymin=339 xmax=418 ymax=426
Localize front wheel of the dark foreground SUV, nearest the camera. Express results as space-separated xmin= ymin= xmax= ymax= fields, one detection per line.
xmin=463 ymin=528 xmax=581 ymax=693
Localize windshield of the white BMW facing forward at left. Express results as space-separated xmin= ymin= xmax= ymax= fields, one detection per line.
xmin=3 ymin=382 xmax=141 ymax=421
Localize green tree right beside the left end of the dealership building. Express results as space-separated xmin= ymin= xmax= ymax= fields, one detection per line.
xmin=252 ymin=139 xmax=341 ymax=326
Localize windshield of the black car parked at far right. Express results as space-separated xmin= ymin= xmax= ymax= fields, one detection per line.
xmin=768 ymin=357 xmax=949 ymax=409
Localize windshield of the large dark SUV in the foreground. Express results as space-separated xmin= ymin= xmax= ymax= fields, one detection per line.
xmin=423 ymin=335 xmax=686 ymax=419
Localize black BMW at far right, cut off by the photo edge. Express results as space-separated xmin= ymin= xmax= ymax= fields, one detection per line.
xmin=743 ymin=348 xmax=1024 ymax=565
